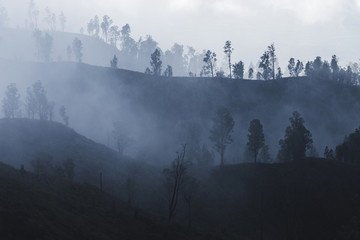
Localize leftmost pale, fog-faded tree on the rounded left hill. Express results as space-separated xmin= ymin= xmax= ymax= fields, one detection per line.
xmin=2 ymin=83 xmax=20 ymax=118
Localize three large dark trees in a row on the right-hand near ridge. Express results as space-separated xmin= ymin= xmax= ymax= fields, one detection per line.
xmin=210 ymin=107 xmax=315 ymax=166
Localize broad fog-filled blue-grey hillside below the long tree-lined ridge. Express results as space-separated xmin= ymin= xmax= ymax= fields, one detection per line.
xmin=0 ymin=61 xmax=360 ymax=164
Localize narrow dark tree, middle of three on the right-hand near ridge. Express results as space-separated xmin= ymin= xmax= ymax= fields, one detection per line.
xmin=247 ymin=119 xmax=265 ymax=163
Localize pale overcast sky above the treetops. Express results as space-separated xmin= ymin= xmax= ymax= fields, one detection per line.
xmin=0 ymin=0 xmax=360 ymax=66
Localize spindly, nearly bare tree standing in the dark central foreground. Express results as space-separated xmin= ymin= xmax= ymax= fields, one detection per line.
xmin=163 ymin=145 xmax=191 ymax=222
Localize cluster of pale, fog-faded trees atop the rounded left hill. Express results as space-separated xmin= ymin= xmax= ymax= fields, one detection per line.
xmin=2 ymin=81 xmax=69 ymax=125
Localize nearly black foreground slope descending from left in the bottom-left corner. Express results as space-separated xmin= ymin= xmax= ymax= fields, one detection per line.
xmin=0 ymin=163 xmax=220 ymax=240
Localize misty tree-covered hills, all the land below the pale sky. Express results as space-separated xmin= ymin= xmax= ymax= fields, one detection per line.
xmin=0 ymin=0 xmax=360 ymax=240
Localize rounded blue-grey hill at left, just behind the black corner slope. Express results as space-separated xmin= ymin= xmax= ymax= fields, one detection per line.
xmin=0 ymin=119 xmax=161 ymax=209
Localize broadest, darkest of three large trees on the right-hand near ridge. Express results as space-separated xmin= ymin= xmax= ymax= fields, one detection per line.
xmin=278 ymin=111 xmax=313 ymax=162
